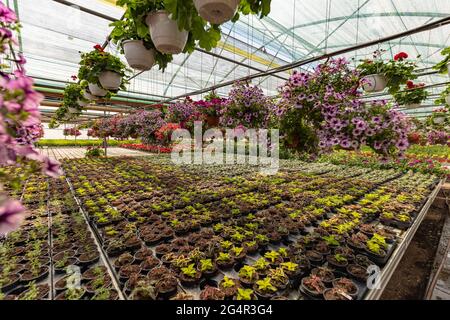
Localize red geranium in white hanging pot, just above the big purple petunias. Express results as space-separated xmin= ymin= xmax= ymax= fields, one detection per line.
xmin=357 ymin=51 xmax=417 ymax=94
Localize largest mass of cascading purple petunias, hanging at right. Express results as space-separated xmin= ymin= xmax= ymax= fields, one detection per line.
xmin=276 ymin=59 xmax=409 ymax=156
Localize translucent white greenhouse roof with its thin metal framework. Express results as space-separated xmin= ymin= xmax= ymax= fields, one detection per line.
xmin=9 ymin=0 xmax=450 ymax=117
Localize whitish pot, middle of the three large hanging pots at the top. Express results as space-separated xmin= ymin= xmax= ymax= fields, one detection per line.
xmin=146 ymin=10 xmax=189 ymax=54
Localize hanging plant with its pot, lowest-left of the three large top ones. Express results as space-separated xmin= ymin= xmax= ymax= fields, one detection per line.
xmin=110 ymin=17 xmax=173 ymax=72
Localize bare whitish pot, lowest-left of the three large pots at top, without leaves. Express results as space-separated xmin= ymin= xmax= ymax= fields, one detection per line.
xmin=123 ymin=40 xmax=155 ymax=71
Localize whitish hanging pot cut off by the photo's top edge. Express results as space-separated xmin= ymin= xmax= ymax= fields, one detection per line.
xmin=194 ymin=0 xmax=240 ymax=24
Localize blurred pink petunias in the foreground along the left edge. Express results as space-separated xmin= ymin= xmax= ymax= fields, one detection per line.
xmin=0 ymin=1 xmax=61 ymax=235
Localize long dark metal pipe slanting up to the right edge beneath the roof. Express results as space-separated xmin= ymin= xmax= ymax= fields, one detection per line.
xmin=149 ymin=16 xmax=450 ymax=103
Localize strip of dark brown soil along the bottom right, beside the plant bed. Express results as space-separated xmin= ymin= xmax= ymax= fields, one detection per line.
xmin=381 ymin=196 xmax=448 ymax=300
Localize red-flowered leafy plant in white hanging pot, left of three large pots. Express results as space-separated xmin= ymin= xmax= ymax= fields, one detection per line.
xmin=78 ymin=45 xmax=127 ymax=97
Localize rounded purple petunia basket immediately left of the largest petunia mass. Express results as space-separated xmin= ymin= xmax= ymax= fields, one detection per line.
xmin=220 ymin=82 xmax=274 ymax=128
